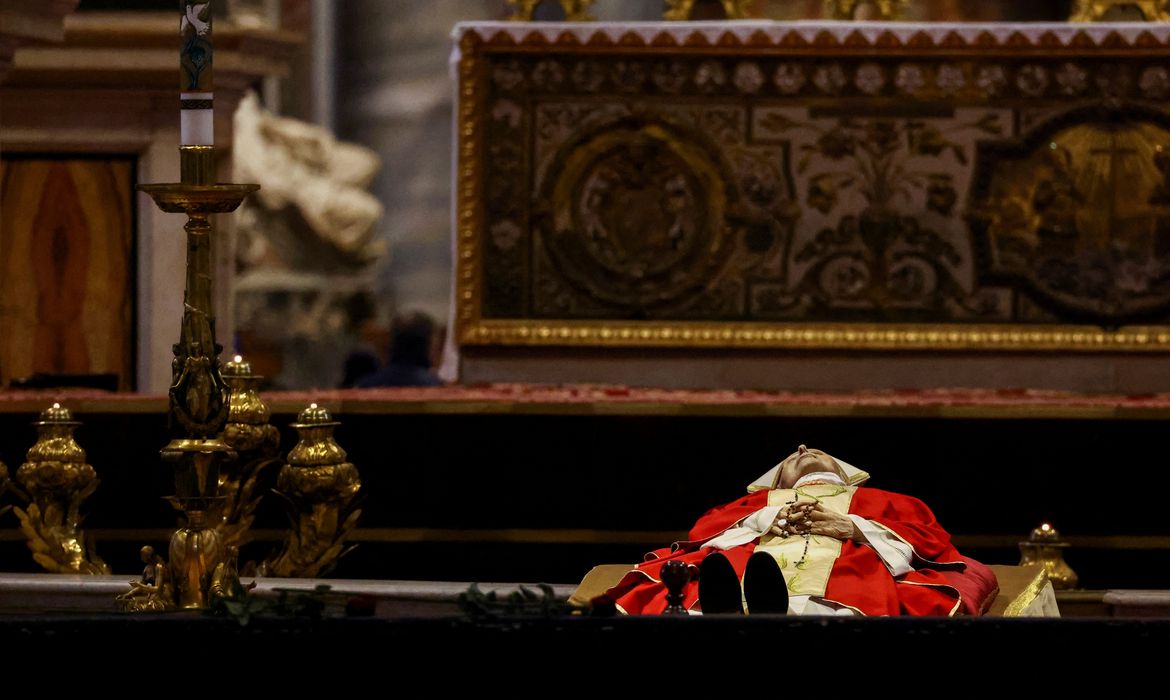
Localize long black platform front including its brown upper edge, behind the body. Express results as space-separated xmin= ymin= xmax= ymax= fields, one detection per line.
xmin=0 ymin=385 xmax=1170 ymax=590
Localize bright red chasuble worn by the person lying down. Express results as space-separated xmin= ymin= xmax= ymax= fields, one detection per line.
xmin=601 ymin=487 xmax=965 ymax=616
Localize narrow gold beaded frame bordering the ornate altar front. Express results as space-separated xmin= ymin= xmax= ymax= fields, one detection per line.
xmin=455 ymin=24 xmax=1170 ymax=352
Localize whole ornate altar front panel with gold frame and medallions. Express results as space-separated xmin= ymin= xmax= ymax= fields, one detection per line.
xmin=453 ymin=21 xmax=1170 ymax=362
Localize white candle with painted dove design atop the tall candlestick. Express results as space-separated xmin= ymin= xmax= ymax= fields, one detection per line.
xmin=179 ymin=0 xmax=215 ymax=146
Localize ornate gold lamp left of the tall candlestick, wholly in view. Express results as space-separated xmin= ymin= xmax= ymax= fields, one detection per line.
xmin=12 ymin=404 xmax=110 ymax=574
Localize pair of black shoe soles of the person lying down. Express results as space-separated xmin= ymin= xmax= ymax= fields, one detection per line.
xmin=698 ymin=551 xmax=789 ymax=615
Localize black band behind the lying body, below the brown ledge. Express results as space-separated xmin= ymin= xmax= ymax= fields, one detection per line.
xmin=0 ymin=412 xmax=1170 ymax=589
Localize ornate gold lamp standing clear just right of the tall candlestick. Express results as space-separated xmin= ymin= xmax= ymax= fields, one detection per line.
xmin=261 ymin=404 xmax=362 ymax=577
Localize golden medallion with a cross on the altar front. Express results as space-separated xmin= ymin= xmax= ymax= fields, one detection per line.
xmin=971 ymin=108 xmax=1170 ymax=322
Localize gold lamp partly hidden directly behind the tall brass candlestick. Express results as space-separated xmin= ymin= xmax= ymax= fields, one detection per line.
xmin=218 ymin=355 xmax=281 ymax=557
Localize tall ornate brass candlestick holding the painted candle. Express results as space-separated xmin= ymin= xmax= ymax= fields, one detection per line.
xmin=123 ymin=146 xmax=260 ymax=610
